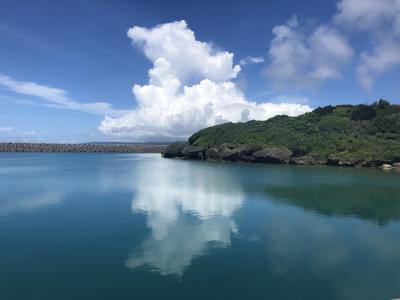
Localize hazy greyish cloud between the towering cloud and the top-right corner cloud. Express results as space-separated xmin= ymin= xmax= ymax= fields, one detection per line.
xmin=266 ymin=17 xmax=353 ymax=89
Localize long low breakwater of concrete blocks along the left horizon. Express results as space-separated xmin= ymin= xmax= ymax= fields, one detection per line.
xmin=0 ymin=143 xmax=167 ymax=153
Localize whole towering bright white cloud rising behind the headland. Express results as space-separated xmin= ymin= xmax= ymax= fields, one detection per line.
xmin=99 ymin=21 xmax=311 ymax=139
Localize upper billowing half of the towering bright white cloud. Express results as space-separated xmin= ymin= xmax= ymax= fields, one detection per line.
xmin=128 ymin=21 xmax=240 ymax=83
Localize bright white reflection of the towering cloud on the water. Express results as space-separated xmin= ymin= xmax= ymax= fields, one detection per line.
xmin=126 ymin=161 xmax=243 ymax=276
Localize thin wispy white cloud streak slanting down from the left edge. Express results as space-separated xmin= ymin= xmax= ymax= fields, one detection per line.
xmin=0 ymin=74 xmax=127 ymax=116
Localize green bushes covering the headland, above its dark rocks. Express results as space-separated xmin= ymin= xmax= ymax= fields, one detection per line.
xmin=189 ymin=100 xmax=400 ymax=161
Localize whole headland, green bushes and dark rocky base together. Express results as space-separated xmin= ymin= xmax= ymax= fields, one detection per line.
xmin=163 ymin=100 xmax=400 ymax=169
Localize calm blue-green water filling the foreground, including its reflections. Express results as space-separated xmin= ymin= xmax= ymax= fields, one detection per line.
xmin=0 ymin=153 xmax=400 ymax=300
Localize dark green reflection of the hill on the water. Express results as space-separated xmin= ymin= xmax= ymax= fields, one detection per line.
xmin=265 ymin=182 xmax=400 ymax=224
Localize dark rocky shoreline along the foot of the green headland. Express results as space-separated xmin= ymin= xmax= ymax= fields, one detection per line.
xmin=162 ymin=144 xmax=400 ymax=170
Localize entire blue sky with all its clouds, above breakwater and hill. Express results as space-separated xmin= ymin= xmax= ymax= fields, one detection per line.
xmin=0 ymin=0 xmax=400 ymax=142
